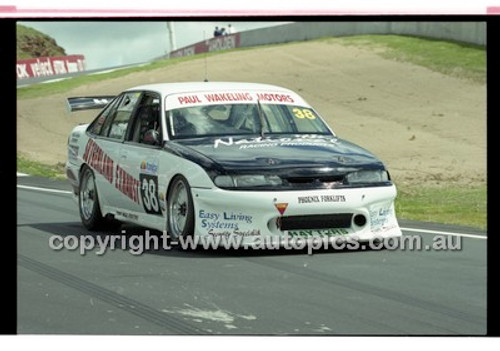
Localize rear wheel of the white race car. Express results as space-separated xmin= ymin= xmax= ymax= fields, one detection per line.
xmin=78 ymin=166 xmax=105 ymax=230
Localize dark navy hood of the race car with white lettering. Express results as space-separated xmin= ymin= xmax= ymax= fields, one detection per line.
xmin=166 ymin=135 xmax=385 ymax=176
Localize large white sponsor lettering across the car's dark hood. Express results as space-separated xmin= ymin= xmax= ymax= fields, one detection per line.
xmin=214 ymin=134 xmax=337 ymax=149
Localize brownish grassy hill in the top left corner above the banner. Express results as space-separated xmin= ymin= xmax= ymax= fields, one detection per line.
xmin=16 ymin=24 xmax=66 ymax=60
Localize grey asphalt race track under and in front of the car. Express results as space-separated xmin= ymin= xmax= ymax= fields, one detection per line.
xmin=17 ymin=177 xmax=487 ymax=335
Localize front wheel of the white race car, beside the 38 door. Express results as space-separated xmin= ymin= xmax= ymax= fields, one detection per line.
xmin=167 ymin=175 xmax=194 ymax=241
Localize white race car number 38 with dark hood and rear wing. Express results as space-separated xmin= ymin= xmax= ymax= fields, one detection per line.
xmin=66 ymin=82 xmax=401 ymax=248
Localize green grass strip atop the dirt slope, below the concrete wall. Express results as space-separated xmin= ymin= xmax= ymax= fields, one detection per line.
xmin=323 ymin=35 xmax=486 ymax=83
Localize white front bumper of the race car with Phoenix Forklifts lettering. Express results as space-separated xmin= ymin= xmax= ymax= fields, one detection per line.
xmin=192 ymin=185 xmax=401 ymax=248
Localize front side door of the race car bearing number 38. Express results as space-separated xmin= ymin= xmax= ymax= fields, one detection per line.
xmin=112 ymin=92 xmax=165 ymax=227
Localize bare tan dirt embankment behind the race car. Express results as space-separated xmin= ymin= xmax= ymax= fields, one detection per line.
xmin=17 ymin=42 xmax=486 ymax=188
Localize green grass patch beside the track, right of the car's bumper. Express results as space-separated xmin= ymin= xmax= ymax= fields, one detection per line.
xmin=396 ymin=185 xmax=487 ymax=229
